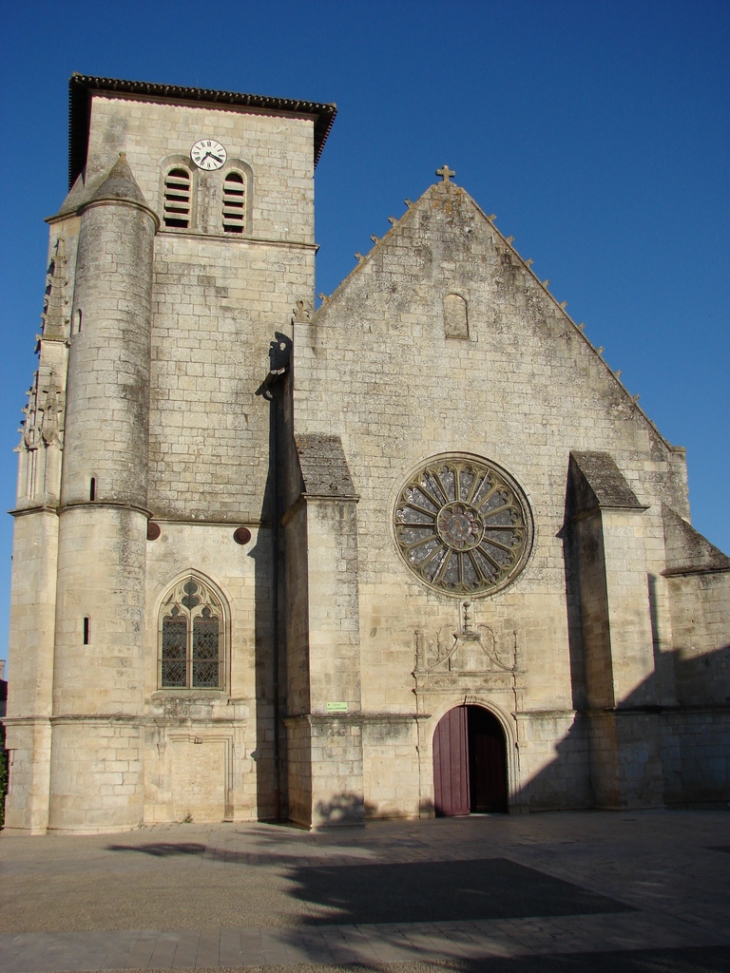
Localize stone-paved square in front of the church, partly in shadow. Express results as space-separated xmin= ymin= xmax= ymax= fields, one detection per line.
xmin=0 ymin=811 xmax=730 ymax=973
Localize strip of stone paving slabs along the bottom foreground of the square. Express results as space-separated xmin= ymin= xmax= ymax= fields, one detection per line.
xmin=0 ymin=913 xmax=730 ymax=973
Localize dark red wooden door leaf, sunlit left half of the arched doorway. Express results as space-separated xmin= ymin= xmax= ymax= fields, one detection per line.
xmin=433 ymin=706 xmax=469 ymax=817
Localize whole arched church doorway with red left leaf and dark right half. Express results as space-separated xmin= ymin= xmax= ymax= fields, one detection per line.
xmin=433 ymin=706 xmax=507 ymax=817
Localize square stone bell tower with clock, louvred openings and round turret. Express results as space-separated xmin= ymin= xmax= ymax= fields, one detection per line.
xmin=6 ymin=75 xmax=336 ymax=833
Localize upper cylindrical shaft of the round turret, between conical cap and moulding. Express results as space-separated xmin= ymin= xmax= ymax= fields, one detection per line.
xmin=62 ymin=194 xmax=156 ymax=506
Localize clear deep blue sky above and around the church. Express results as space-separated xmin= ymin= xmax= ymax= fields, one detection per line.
xmin=0 ymin=0 xmax=730 ymax=658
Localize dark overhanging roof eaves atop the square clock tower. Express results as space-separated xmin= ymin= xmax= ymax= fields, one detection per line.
xmin=68 ymin=74 xmax=337 ymax=188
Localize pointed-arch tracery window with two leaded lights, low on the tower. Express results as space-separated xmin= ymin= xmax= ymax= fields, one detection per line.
xmin=159 ymin=575 xmax=226 ymax=689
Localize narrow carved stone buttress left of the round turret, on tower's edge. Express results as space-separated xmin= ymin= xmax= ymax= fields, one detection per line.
xmin=6 ymin=217 xmax=79 ymax=834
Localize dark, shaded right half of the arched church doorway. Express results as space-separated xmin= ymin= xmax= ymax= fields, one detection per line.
xmin=468 ymin=706 xmax=507 ymax=811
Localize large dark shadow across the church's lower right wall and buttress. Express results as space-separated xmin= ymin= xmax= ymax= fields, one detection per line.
xmin=517 ymin=645 xmax=730 ymax=810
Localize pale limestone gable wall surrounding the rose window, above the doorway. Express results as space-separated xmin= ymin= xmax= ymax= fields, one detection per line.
xmin=293 ymin=184 xmax=686 ymax=808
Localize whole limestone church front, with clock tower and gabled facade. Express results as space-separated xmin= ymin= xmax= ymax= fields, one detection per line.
xmin=4 ymin=75 xmax=730 ymax=833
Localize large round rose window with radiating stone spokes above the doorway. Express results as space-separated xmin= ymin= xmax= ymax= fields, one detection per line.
xmin=394 ymin=455 xmax=532 ymax=597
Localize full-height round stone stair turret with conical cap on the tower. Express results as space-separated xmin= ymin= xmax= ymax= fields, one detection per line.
xmin=49 ymin=155 xmax=157 ymax=831
